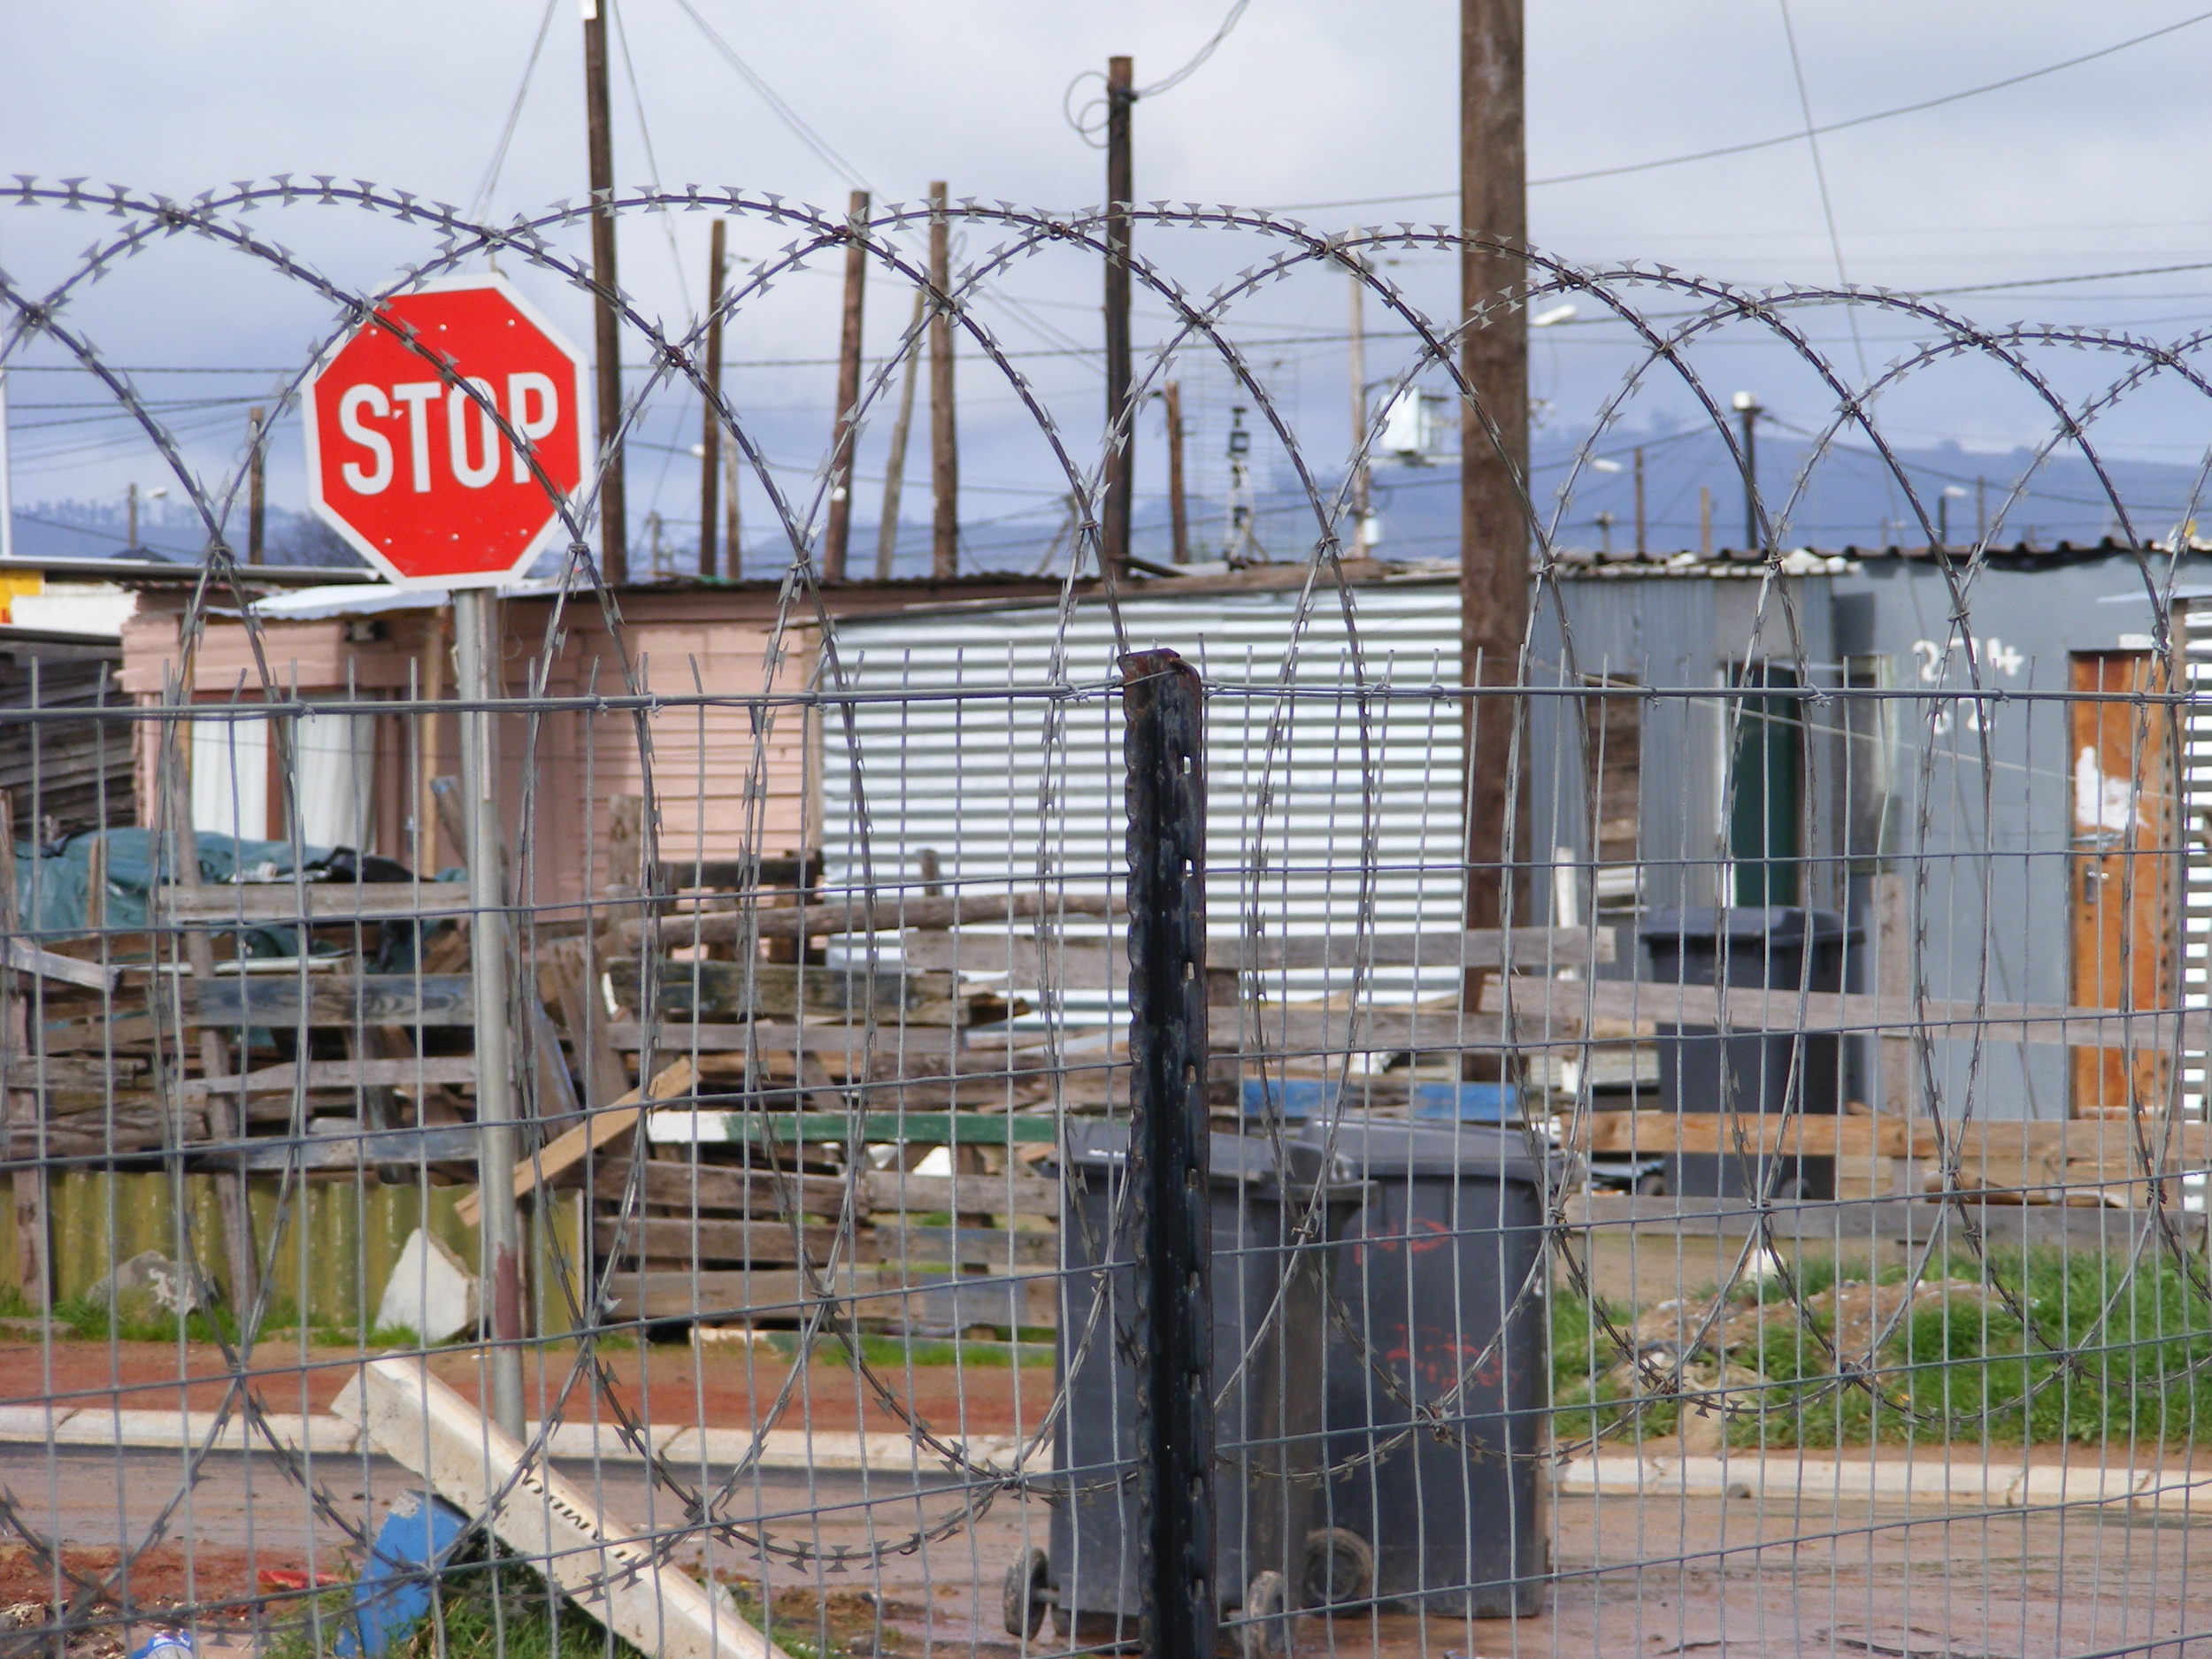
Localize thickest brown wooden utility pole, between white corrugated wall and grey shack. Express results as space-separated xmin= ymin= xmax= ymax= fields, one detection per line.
xmin=1460 ymin=0 xmax=1529 ymax=956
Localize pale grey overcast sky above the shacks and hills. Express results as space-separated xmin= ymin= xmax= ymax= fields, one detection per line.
xmin=0 ymin=0 xmax=2212 ymax=559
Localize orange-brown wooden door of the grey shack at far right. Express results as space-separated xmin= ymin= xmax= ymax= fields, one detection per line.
xmin=2066 ymin=650 xmax=2181 ymax=1118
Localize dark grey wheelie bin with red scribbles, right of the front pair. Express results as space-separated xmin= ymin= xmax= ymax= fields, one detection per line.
xmin=1299 ymin=1115 xmax=1551 ymax=1619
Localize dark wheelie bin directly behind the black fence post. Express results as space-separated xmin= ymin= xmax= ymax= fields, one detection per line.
xmin=1007 ymin=1122 xmax=1361 ymax=1659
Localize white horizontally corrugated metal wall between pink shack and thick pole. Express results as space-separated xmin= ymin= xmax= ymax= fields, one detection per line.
xmin=821 ymin=584 xmax=1464 ymax=994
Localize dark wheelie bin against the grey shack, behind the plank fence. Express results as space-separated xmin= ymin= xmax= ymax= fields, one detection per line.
xmin=1637 ymin=905 xmax=1852 ymax=1199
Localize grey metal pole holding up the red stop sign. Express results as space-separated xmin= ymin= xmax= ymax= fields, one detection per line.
xmin=454 ymin=588 xmax=522 ymax=1440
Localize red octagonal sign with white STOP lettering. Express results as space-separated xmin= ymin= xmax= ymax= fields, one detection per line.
xmin=305 ymin=277 xmax=587 ymax=588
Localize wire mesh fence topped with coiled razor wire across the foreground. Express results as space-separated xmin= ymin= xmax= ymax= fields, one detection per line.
xmin=12 ymin=181 xmax=2212 ymax=1659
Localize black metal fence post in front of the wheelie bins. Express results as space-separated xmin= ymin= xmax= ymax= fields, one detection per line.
xmin=1122 ymin=650 xmax=1221 ymax=1659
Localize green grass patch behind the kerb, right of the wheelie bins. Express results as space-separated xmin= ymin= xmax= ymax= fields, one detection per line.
xmin=1553 ymin=1248 xmax=2212 ymax=1447
